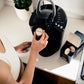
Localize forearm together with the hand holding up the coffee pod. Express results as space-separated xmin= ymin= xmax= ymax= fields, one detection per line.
xmin=20 ymin=31 xmax=48 ymax=84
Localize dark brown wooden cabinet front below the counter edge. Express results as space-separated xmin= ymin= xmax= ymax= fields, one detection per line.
xmin=36 ymin=68 xmax=75 ymax=84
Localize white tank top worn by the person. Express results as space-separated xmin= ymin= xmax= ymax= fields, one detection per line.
xmin=0 ymin=36 xmax=20 ymax=80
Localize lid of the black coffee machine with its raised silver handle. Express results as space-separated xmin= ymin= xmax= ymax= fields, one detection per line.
xmin=36 ymin=0 xmax=56 ymax=21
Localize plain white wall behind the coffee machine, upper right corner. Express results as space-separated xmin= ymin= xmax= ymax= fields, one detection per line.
xmin=52 ymin=0 xmax=84 ymax=18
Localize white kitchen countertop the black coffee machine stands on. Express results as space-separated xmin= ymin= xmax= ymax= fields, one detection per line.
xmin=0 ymin=6 xmax=84 ymax=81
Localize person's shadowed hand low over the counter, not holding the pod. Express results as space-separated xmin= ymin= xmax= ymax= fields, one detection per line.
xmin=14 ymin=42 xmax=31 ymax=53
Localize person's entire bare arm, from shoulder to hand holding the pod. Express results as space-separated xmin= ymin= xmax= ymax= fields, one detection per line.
xmin=0 ymin=31 xmax=48 ymax=84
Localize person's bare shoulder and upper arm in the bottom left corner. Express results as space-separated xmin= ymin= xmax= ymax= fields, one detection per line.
xmin=0 ymin=60 xmax=19 ymax=84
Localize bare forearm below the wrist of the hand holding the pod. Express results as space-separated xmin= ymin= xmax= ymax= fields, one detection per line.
xmin=20 ymin=51 xmax=38 ymax=84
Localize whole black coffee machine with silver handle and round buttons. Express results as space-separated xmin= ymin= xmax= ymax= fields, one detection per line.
xmin=29 ymin=0 xmax=67 ymax=57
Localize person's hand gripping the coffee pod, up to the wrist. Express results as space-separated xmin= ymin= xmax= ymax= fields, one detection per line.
xmin=31 ymin=30 xmax=49 ymax=53
